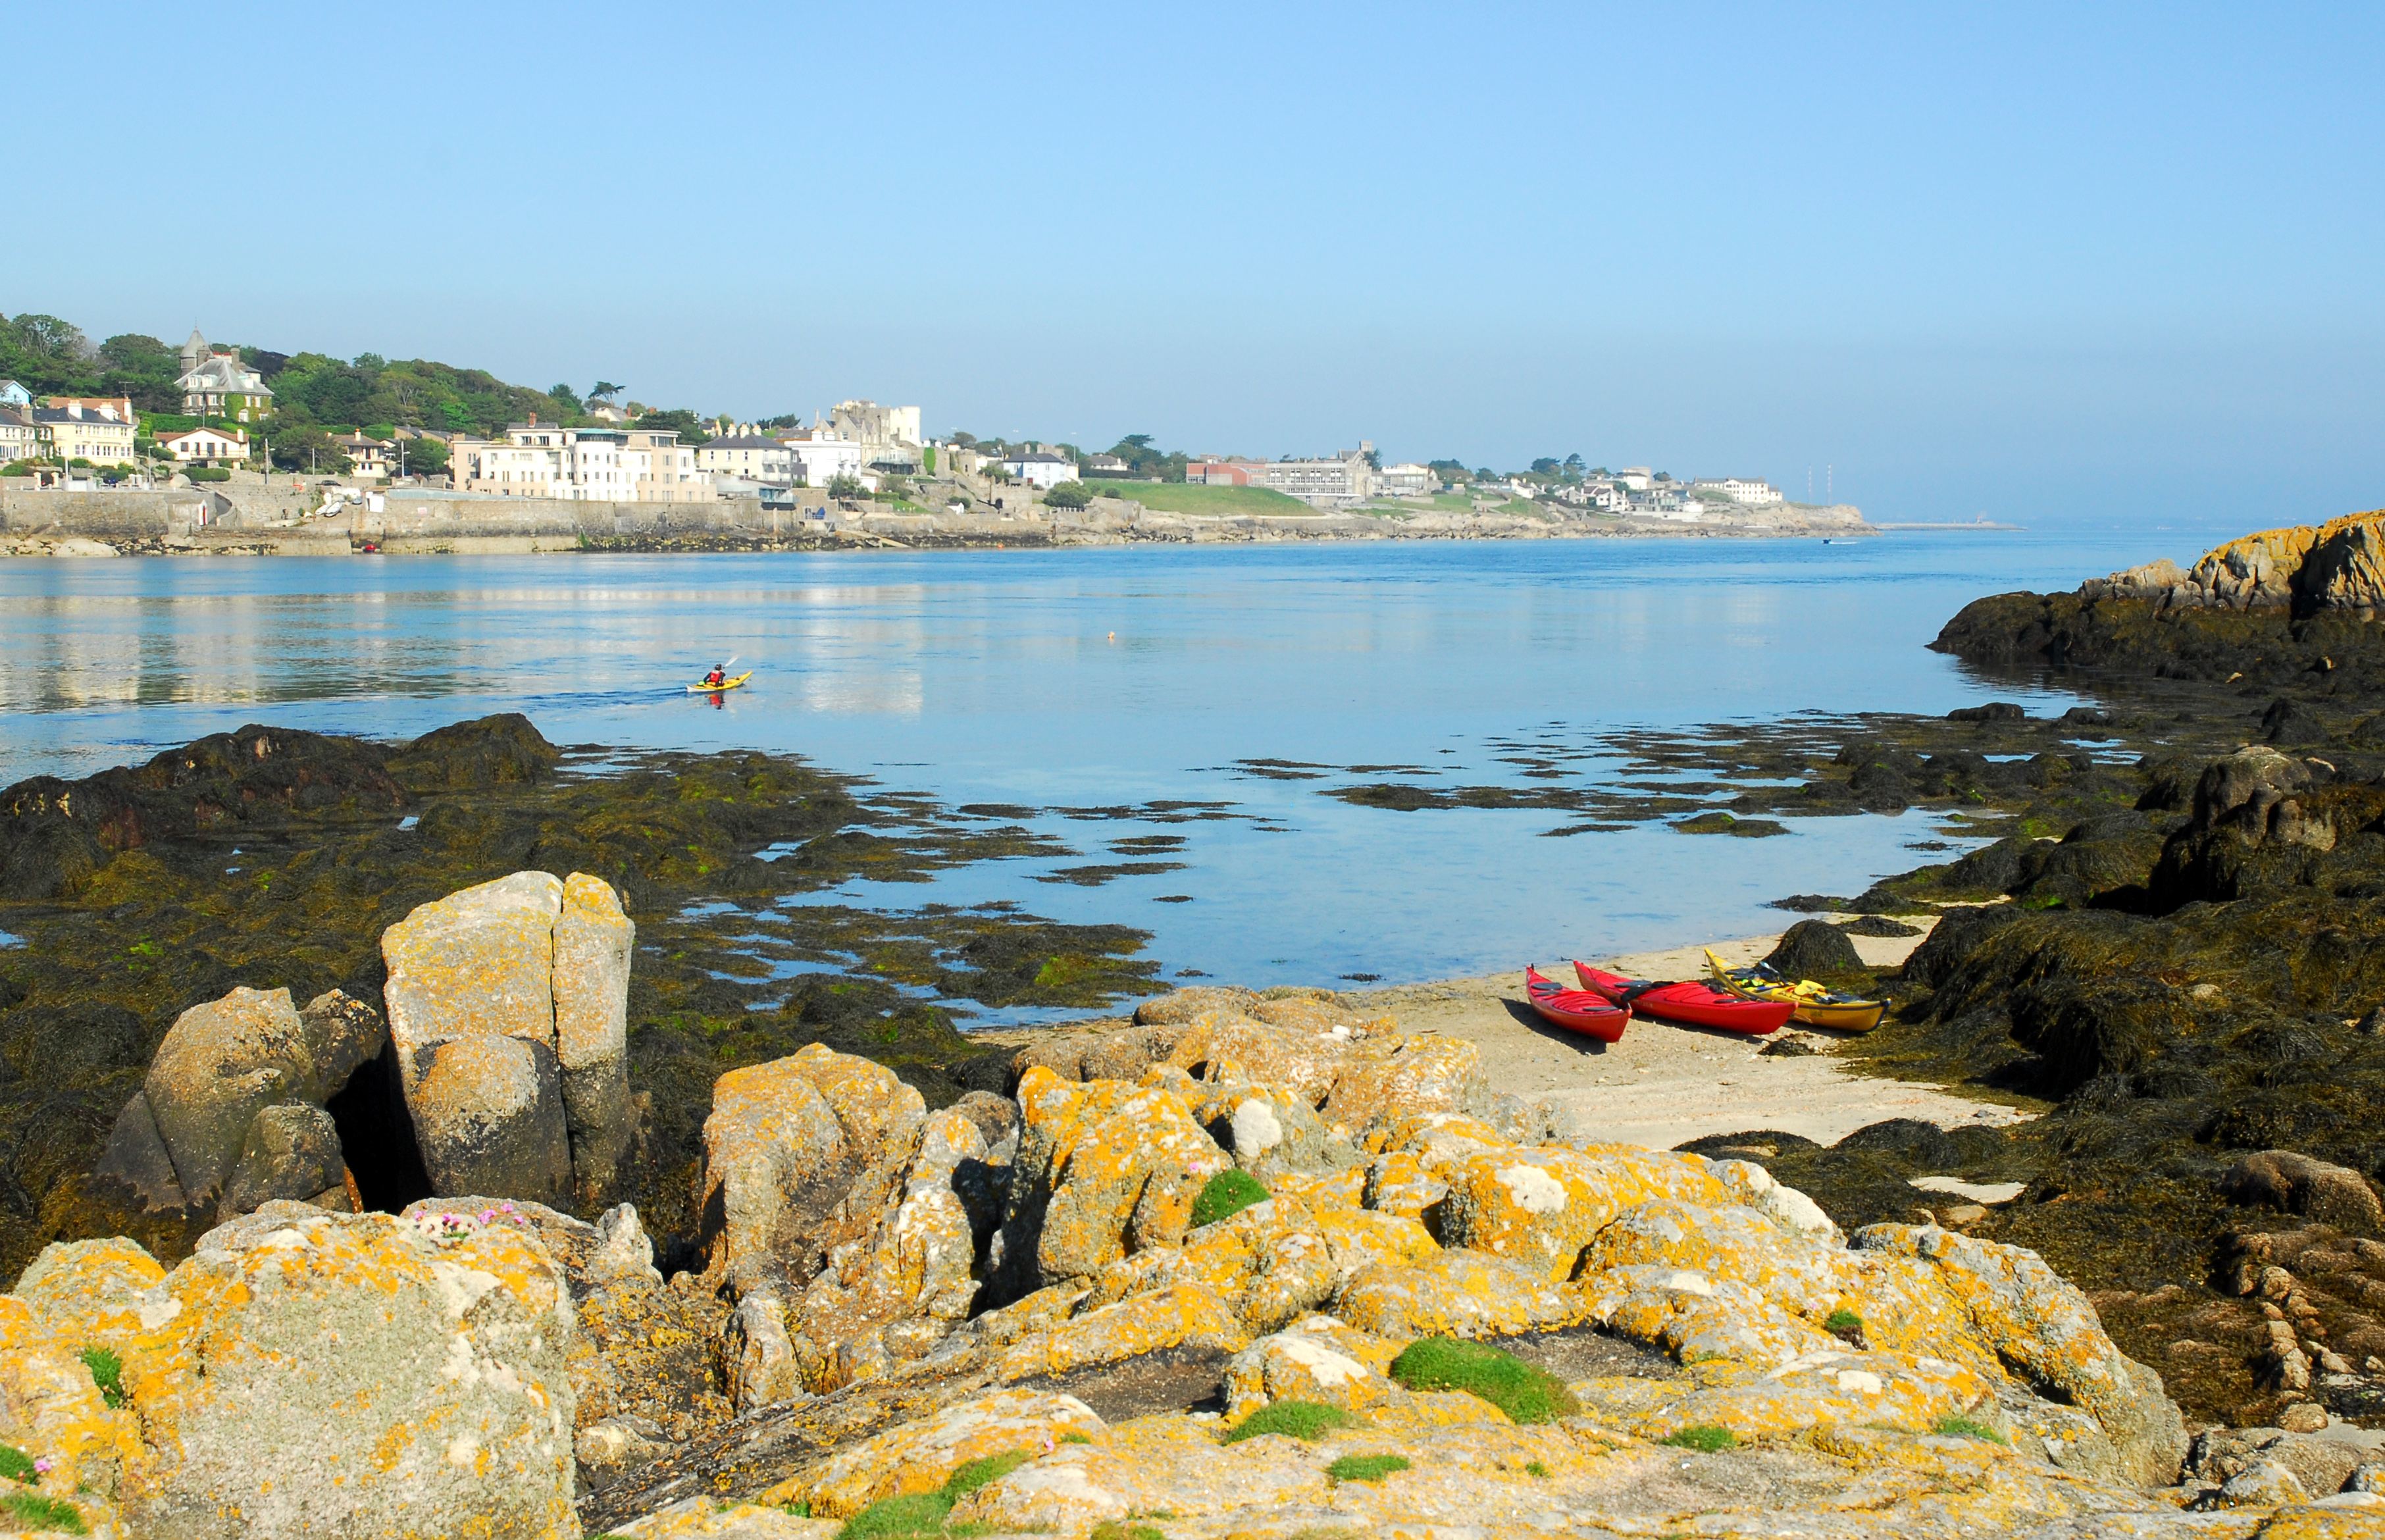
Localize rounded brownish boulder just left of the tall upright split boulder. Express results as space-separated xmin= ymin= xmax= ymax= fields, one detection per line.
xmin=95 ymin=987 xmax=384 ymax=1223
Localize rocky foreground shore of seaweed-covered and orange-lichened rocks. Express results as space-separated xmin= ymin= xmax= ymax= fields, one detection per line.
xmin=0 ymin=515 xmax=2385 ymax=1540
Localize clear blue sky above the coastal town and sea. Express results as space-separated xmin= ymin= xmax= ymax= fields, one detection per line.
xmin=0 ymin=0 xmax=2385 ymax=525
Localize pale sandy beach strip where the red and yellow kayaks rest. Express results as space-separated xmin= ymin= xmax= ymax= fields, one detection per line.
xmin=1343 ymin=920 xmax=2030 ymax=1149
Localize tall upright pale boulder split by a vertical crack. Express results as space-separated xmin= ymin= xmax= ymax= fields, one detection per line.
xmin=382 ymin=873 xmax=637 ymax=1204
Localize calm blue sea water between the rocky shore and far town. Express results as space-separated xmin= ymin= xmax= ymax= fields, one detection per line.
xmin=0 ymin=527 xmax=2232 ymax=985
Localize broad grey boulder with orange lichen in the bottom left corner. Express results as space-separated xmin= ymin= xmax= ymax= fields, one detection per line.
xmin=0 ymin=1204 xmax=580 ymax=1540
